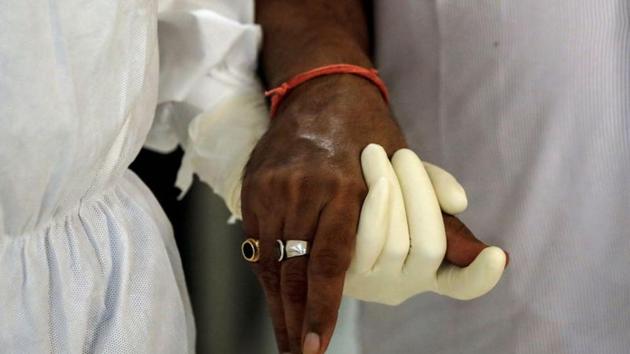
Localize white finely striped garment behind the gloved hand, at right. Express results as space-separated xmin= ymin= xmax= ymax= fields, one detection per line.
xmin=359 ymin=0 xmax=630 ymax=354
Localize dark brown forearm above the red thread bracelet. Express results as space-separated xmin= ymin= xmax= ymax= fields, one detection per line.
xmin=256 ymin=0 xmax=372 ymax=87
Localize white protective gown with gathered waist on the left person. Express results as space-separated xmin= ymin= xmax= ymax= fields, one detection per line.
xmin=0 ymin=0 xmax=260 ymax=353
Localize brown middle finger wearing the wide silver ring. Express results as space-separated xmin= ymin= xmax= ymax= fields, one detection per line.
xmin=281 ymin=197 xmax=321 ymax=353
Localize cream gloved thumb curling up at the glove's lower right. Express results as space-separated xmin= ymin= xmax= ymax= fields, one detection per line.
xmin=436 ymin=247 xmax=507 ymax=300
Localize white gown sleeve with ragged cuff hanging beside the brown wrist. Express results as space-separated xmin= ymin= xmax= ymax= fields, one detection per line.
xmin=150 ymin=0 xmax=269 ymax=221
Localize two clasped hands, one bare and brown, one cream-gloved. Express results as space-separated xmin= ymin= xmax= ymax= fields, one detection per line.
xmin=241 ymin=75 xmax=506 ymax=353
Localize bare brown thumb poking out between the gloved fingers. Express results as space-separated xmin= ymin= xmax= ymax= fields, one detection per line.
xmin=442 ymin=214 xmax=509 ymax=267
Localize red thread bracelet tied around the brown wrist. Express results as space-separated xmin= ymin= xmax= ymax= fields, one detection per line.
xmin=265 ymin=64 xmax=389 ymax=118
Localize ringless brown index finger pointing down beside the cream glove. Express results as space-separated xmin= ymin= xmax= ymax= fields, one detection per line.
xmin=303 ymin=200 xmax=360 ymax=354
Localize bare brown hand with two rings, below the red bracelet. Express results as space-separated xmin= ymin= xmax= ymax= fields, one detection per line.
xmin=242 ymin=75 xmax=504 ymax=353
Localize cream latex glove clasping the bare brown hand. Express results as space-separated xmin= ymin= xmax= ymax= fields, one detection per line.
xmin=344 ymin=144 xmax=506 ymax=305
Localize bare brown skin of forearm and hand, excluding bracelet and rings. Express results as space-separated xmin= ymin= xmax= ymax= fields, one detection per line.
xmin=247 ymin=0 xmax=508 ymax=354
